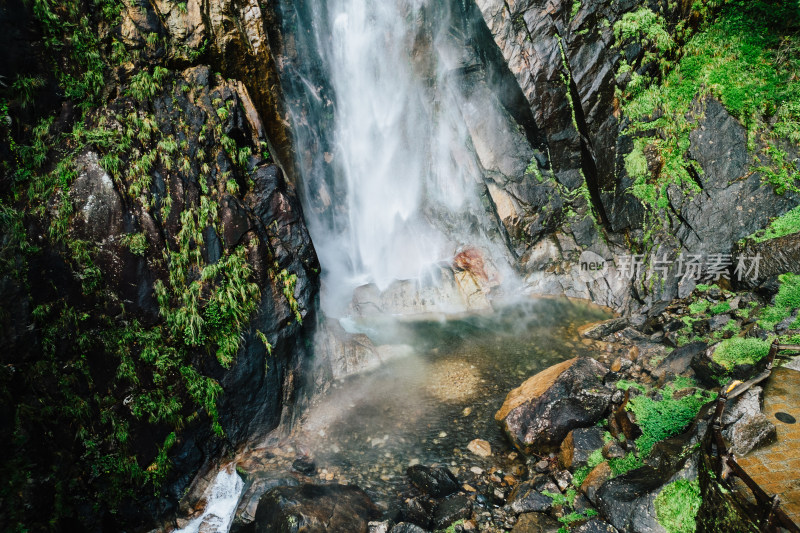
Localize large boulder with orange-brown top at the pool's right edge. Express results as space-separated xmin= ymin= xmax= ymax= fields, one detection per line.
xmin=495 ymin=357 xmax=611 ymax=453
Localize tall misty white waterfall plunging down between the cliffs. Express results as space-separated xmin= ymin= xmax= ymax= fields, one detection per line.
xmin=281 ymin=0 xmax=534 ymax=315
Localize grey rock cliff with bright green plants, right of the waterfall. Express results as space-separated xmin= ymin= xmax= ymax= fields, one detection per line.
xmin=476 ymin=0 xmax=800 ymax=309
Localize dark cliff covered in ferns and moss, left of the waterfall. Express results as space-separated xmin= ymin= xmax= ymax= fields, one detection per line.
xmin=0 ymin=1 xmax=319 ymax=531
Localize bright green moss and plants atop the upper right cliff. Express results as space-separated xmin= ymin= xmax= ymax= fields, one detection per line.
xmin=614 ymin=0 xmax=800 ymax=231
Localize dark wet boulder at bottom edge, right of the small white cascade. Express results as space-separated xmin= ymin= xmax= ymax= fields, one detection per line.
xmin=255 ymin=484 xmax=380 ymax=533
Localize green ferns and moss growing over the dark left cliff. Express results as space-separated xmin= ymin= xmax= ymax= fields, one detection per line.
xmin=0 ymin=0 xmax=288 ymax=531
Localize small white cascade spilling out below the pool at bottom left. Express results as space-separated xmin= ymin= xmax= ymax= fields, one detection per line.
xmin=174 ymin=465 xmax=244 ymax=533
